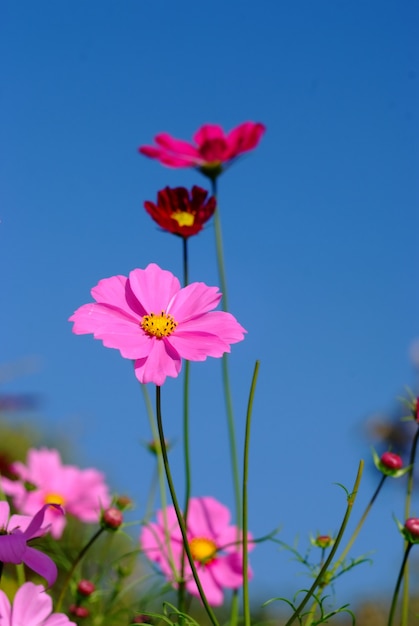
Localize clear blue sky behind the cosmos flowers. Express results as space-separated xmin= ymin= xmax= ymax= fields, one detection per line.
xmin=0 ymin=0 xmax=419 ymax=602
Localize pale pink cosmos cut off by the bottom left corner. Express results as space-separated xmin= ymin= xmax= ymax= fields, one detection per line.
xmin=0 ymin=583 xmax=76 ymax=626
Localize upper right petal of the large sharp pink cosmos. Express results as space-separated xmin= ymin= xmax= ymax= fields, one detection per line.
xmin=167 ymin=283 xmax=222 ymax=323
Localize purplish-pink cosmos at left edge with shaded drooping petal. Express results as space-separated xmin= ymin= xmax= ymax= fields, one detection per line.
xmin=0 ymin=502 xmax=59 ymax=584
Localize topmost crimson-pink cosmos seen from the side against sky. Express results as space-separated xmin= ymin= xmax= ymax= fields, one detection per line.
xmin=139 ymin=122 xmax=265 ymax=178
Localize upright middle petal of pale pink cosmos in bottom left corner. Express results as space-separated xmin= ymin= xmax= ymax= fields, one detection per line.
xmin=13 ymin=582 xmax=52 ymax=626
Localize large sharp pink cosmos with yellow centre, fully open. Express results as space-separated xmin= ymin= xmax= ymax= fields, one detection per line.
xmin=70 ymin=263 xmax=246 ymax=385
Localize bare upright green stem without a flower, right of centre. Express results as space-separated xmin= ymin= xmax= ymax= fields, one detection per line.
xmin=242 ymin=361 xmax=260 ymax=626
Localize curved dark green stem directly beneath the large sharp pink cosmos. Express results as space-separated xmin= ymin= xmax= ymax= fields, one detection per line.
xmin=156 ymin=386 xmax=219 ymax=626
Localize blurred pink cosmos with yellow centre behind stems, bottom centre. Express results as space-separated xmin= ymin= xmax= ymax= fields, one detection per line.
xmin=140 ymin=497 xmax=253 ymax=606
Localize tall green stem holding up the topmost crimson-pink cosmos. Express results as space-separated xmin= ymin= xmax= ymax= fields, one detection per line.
xmin=211 ymin=178 xmax=241 ymax=525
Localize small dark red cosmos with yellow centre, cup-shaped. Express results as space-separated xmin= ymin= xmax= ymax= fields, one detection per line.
xmin=144 ymin=185 xmax=216 ymax=238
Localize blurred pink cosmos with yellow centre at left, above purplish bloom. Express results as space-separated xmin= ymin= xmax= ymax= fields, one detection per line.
xmin=0 ymin=448 xmax=111 ymax=539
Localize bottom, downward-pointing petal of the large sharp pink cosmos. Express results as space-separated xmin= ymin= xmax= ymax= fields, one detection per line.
xmin=134 ymin=337 xmax=182 ymax=386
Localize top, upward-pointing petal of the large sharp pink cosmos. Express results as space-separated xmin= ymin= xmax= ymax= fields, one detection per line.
xmin=129 ymin=263 xmax=180 ymax=312
